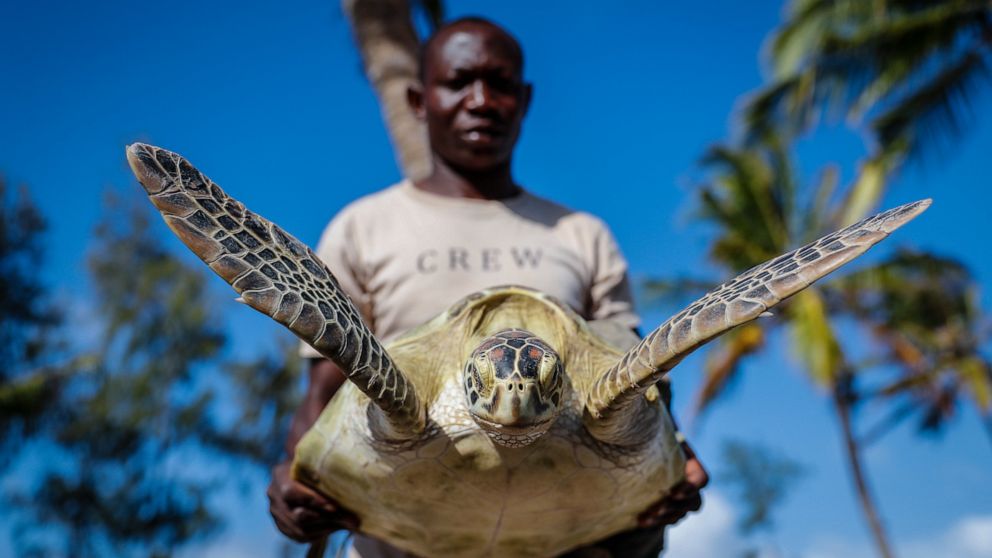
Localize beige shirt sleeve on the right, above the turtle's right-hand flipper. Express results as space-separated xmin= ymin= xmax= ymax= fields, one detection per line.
xmin=589 ymin=219 xmax=641 ymax=329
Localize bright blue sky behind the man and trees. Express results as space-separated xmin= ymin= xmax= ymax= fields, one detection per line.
xmin=0 ymin=0 xmax=992 ymax=557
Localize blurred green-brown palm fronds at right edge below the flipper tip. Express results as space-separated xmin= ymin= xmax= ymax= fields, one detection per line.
xmin=829 ymin=250 xmax=992 ymax=440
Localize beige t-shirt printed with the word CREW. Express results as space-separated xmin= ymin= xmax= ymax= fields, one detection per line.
xmin=302 ymin=181 xmax=638 ymax=357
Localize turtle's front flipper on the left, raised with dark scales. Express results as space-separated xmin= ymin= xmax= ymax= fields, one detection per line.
xmin=127 ymin=143 xmax=425 ymax=439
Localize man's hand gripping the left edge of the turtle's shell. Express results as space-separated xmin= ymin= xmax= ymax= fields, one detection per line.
xmin=266 ymin=463 xmax=359 ymax=542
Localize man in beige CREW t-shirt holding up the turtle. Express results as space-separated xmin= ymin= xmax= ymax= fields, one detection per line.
xmin=268 ymin=18 xmax=708 ymax=558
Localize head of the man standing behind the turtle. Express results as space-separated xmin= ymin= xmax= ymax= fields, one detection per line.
xmin=408 ymin=18 xmax=531 ymax=172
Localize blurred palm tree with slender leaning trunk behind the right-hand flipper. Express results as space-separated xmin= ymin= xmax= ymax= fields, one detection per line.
xmin=648 ymin=133 xmax=992 ymax=556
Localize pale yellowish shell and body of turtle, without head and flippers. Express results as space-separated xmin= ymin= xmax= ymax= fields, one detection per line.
xmin=294 ymin=286 xmax=685 ymax=556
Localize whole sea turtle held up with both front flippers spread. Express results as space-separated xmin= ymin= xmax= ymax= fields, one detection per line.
xmin=127 ymin=144 xmax=930 ymax=557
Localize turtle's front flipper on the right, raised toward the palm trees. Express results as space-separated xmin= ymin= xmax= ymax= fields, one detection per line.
xmin=585 ymin=199 xmax=930 ymax=443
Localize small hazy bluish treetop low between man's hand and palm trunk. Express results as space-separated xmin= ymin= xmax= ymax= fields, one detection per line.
xmin=717 ymin=440 xmax=805 ymax=535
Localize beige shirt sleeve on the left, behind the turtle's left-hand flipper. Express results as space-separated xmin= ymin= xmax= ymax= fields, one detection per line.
xmin=299 ymin=208 xmax=375 ymax=358
